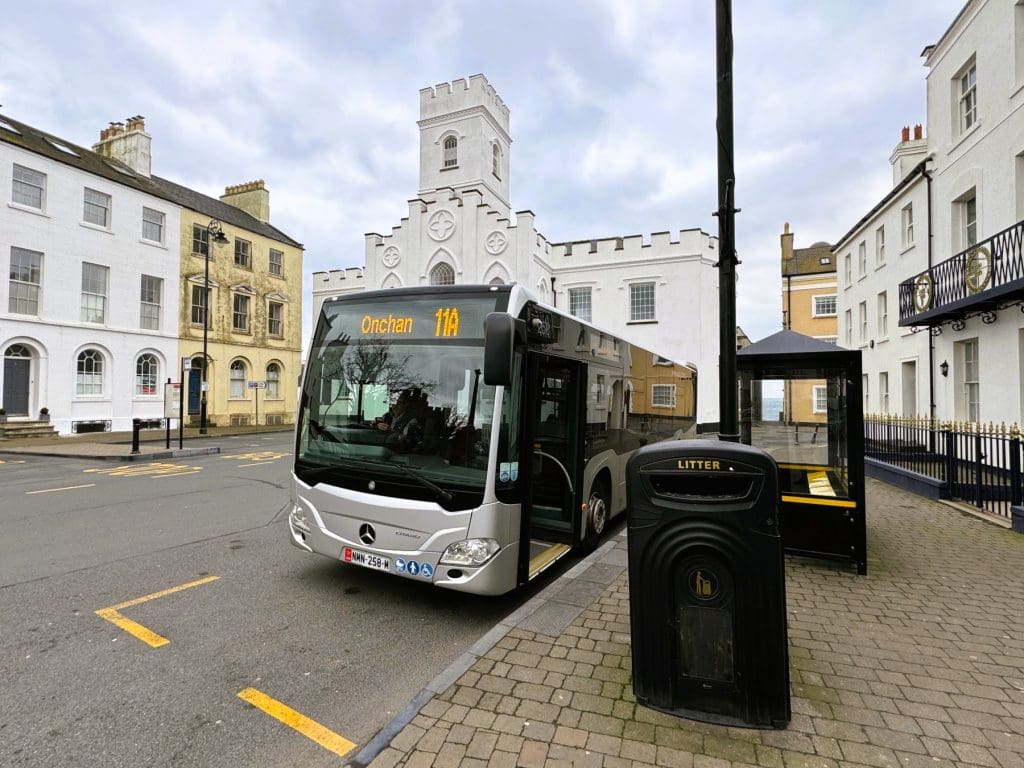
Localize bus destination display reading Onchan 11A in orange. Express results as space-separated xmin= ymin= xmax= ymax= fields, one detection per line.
xmin=325 ymin=296 xmax=495 ymax=341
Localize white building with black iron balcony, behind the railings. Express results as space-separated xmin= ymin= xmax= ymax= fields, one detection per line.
xmin=835 ymin=0 xmax=1024 ymax=424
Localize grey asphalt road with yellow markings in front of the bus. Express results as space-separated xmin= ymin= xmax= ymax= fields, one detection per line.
xmin=0 ymin=433 xmax=537 ymax=768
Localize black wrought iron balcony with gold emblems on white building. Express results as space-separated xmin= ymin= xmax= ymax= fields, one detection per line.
xmin=899 ymin=221 xmax=1024 ymax=327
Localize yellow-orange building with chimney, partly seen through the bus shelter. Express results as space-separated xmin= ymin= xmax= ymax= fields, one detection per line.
xmin=778 ymin=223 xmax=839 ymax=423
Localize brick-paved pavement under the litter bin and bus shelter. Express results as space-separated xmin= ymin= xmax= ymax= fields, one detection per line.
xmin=351 ymin=480 xmax=1024 ymax=768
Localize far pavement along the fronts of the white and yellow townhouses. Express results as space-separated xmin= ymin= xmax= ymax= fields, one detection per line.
xmin=0 ymin=426 xmax=295 ymax=461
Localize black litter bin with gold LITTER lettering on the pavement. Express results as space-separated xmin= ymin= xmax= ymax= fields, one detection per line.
xmin=627 ymin=440 xmax=791 ymax=728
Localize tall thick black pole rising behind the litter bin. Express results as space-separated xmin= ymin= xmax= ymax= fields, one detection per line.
xmin=715 ymin=0 xmax=739 ymax=442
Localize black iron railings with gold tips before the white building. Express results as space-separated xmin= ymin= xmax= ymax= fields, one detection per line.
xmin=864 ymin=416 xmax=1024 ymax=519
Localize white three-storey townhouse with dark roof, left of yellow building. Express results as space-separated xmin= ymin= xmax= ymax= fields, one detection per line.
xmin=0 ymin=115 xmax=181 ymax=434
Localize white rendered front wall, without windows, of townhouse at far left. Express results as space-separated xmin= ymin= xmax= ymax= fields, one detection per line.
xmin=0 ymin=143 xmax=180 ymax=434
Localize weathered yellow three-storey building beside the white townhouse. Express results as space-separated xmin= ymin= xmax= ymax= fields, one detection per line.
xmin=179 ymin=180 xmax=302 ymax=426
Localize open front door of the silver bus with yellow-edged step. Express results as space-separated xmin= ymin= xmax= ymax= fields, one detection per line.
xmin=520 ymin=354 xmax=586 ymax=580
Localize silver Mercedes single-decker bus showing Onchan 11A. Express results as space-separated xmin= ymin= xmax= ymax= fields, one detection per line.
xmin=288 ymin=285 xmax=697 ymax=595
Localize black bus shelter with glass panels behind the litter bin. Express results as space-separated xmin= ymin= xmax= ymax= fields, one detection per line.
xmin=736 ymin=331 xmax=867 ymax=574
